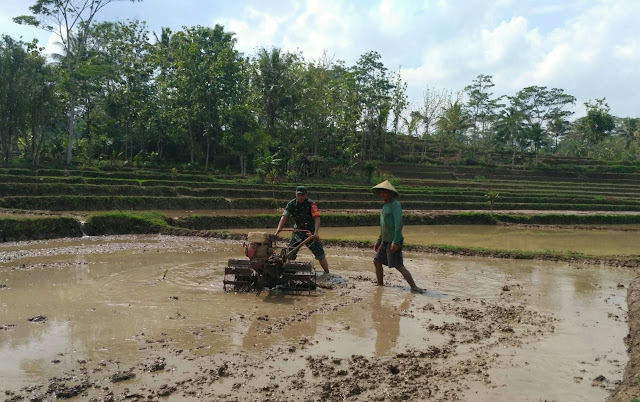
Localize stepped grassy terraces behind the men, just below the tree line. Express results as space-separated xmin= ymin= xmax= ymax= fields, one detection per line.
xmin=0 ymin=167 xmax=640 ymax=212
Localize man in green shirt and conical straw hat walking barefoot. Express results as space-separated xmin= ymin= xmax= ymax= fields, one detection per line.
xmin=371 ymin=180 xmax=422 ymax=292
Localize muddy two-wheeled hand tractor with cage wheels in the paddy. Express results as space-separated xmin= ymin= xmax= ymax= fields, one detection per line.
xmin=223 ymin=229 xmax=317 ymax=294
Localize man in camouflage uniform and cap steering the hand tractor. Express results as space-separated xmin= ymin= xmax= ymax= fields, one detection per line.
xmin=276 ymin=186 xmax=329 ymax=274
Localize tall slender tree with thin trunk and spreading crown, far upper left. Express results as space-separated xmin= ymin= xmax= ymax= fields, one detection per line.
xmin=13 ymin=0 xmax=141 ymax=165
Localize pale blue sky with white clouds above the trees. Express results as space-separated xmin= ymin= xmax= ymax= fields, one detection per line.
xmin=0 ymin=0 xmax=640 ymax=117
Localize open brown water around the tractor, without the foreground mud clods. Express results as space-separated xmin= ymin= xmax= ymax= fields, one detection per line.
xmin=0 ymin=234 xmax=633 ymax=401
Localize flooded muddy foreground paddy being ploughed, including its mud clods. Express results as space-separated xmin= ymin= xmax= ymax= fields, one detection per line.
xmin=0 ymin=234 xmax=633 ymax=401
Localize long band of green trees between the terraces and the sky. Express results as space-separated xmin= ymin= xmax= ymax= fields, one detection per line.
xmin=0 ymin=0 xmax=640 ymax=180
